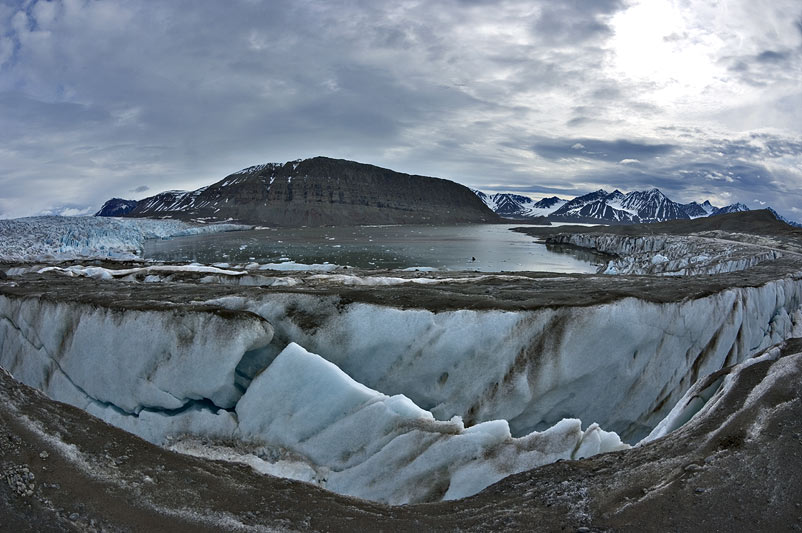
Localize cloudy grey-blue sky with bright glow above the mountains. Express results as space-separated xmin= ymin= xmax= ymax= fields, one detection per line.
xmin=0 ymin=0 xmax=802 ymax=220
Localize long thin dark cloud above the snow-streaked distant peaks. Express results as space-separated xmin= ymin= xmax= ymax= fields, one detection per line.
xmin=531 ymin=138 xmax=676 ymax=162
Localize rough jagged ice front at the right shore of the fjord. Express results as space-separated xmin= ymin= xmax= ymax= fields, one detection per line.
xmin=546 ymin=233 xmax=781 ymax=276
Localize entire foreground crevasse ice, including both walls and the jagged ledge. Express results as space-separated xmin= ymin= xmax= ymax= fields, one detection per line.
xmin=0 ymin=276 xmax=802 ymax=503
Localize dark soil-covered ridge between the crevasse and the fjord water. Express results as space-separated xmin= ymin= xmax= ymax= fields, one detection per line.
xmin=0 ymin=252 xmax=802 ymax=312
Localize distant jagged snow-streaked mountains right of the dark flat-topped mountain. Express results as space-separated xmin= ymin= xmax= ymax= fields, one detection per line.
xmin=473 ymin=189 xmax=802 ymax=227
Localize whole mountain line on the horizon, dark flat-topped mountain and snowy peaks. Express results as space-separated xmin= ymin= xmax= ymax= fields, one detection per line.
xmin=96 ymin=157 xmax=802 ymax=227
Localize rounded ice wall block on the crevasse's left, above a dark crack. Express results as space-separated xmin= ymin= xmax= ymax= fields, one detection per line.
xmin=0 ymin=296 xmax=273 ymax=415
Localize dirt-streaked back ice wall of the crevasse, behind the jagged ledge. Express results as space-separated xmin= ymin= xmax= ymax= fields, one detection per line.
xmin=213 ymin=275 xmax=802 ymax=442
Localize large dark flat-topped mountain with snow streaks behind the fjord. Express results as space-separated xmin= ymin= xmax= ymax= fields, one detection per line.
xmin=117 ymin=157 xmax=499 ymax=226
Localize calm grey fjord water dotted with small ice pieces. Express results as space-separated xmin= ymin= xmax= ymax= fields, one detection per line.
xmin=144 ymin=224 xmax=602 ymax=273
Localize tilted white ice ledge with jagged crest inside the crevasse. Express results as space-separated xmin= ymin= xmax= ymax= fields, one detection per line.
xmin=236 ymin=343 xmax=628 ymax=504
